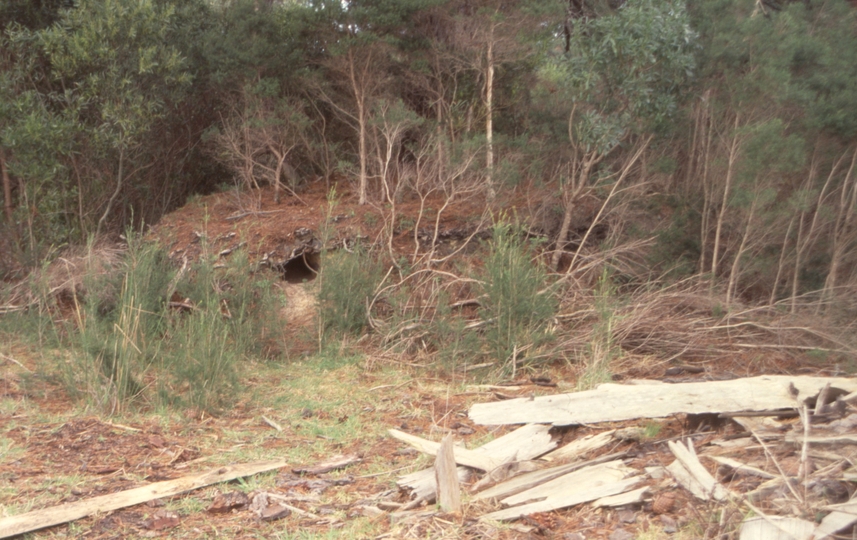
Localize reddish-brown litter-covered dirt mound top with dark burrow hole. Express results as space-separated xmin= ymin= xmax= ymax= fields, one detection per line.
xmin=149 ymin=182 xmax=488 ymax=283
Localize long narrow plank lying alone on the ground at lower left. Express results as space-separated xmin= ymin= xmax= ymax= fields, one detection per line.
xmin=0 ymin=460 xmax=286 ymax=538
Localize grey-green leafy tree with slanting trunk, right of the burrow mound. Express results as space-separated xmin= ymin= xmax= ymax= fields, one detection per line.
xmin=540 ymin=0 xmax=694 ymax=268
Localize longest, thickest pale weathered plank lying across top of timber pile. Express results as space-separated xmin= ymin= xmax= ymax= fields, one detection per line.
xmin=470 ymin=375 xmax=857 ymax=425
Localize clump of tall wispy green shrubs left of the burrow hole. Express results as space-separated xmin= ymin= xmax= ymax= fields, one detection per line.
xmin=3 ymin=234 xmax=283 ymax=414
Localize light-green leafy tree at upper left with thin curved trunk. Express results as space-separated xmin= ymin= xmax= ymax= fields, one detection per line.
xmin=39 ymin=0 xmax=190 ymax=235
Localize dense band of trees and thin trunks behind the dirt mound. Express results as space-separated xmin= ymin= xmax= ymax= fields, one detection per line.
xmin=0 ymin=0 xmax=857 ymax=306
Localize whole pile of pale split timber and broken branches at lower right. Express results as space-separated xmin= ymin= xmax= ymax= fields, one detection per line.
xmin=390 ymin=376 xmax=857 ymax=540
